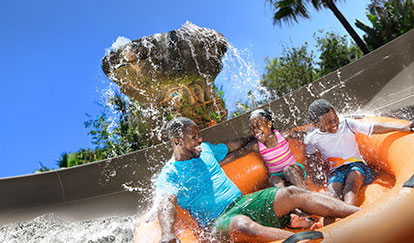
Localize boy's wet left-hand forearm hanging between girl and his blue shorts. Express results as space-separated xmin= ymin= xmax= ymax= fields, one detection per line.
xmin=304 ymin=151 xmax=329 ymax=185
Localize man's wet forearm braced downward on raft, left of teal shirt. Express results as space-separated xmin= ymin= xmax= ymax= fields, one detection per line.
xmin=158 ymin=195 xmax=180 ymax=243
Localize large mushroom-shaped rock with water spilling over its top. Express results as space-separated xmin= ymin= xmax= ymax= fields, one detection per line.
xmin=102 ymin=22 xmax=227 ymax=134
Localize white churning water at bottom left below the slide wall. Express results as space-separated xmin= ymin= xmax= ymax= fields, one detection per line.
xmin=0 ymin=214 xmax=139 ymax=243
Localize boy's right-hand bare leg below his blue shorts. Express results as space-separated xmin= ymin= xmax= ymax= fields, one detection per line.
xmin=343 ymin=170 xmax=364 ymax=205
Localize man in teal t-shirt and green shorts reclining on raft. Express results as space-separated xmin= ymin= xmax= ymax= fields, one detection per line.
xmin=156 ymin=117 xmax=359 ymax=242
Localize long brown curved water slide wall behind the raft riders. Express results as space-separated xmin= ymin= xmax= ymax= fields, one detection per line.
xmin=0 ymin=30 xmax=414 ymax=229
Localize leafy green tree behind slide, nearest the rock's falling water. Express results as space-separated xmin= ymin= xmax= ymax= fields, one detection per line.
xmin=260 ymin=43 xmax=317 ymax=98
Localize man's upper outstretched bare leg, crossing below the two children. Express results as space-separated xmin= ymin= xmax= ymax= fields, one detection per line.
xmin=273 ymin=186 xmax=359 ymax=218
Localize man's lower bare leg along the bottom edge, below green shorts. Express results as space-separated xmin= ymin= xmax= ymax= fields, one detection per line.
xmin=229 ymin=215 xmax=293 ymax=242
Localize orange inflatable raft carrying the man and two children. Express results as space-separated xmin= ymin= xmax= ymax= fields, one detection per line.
xmin=135 ymin=117 xmax=414 ymax=243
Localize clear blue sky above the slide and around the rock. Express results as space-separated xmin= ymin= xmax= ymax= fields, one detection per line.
xmin=0 ymin=0 xmax=369 ymax=178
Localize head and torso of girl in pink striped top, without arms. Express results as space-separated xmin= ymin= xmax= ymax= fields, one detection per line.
xmin=249 ymin=109 xmax=307 ymax=189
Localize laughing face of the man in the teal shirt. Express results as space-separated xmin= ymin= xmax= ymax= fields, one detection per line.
xmin=177 ymin=124 xmax=203 ymax=160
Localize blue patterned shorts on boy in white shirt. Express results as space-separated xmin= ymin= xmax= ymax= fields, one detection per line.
xmin=328 ymin=161 xmax=375 ymax=186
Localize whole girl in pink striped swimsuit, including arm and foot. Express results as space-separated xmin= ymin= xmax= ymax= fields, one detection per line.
xmin=222 ymin=109 xmax=322 ymax=229
